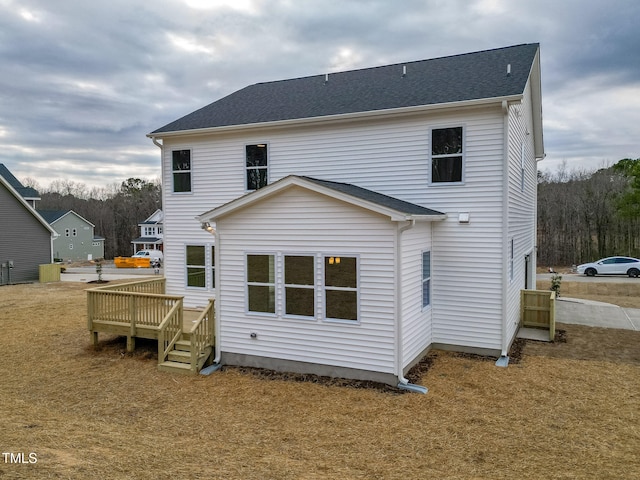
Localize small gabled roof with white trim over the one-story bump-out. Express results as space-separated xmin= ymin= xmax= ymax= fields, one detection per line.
xmin=196 ymin=175 xmax=446 ymax=222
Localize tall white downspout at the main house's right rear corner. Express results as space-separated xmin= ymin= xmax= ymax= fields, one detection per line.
xmin=496 ymin=100 xmax=509 ymax=367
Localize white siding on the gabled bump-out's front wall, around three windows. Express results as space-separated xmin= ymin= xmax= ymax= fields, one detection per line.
xmin=216 ymin=187 xmax=396 ymax=373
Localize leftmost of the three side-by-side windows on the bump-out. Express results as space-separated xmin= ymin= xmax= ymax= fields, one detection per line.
xmin=247 ymin=254 xmax=276 ymax=314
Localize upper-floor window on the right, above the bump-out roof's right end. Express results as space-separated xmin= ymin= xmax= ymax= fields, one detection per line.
xmin=431 ymin=127 xmax=463 ymax=183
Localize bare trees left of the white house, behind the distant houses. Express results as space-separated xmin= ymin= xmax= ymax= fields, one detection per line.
xmin=22 ymin=178 xmax=162 ymax=259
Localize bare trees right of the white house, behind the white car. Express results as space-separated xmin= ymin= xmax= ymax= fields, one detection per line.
xmin=538 ymin=158 xmax=640 ymax=267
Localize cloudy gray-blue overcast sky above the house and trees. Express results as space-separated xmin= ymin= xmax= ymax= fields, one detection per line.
xmin=0 ymin=0 xmax=640 ymax=191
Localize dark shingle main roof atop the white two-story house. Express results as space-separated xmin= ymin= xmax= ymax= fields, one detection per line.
xmin=150 ymin=43 xmax=539 ymax=135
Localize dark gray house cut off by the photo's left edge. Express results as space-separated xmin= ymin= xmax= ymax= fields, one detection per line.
xmin=0 ymin=164 xmax=55 ymax=285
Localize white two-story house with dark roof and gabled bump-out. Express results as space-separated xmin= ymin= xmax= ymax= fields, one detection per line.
xmin=148 ymin=44 xmax=544 ymax=384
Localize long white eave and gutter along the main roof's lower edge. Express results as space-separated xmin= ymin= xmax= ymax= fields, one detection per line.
xmin=147 ymin=94 xmax=523 ymax=139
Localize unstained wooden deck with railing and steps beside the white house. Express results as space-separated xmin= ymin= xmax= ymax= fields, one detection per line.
xmin=87 ymin=278 xmax=215 ymax=373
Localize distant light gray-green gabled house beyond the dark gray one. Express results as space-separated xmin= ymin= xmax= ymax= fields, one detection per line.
xmin=38 ymin=210 xmax=105 ymax=261
